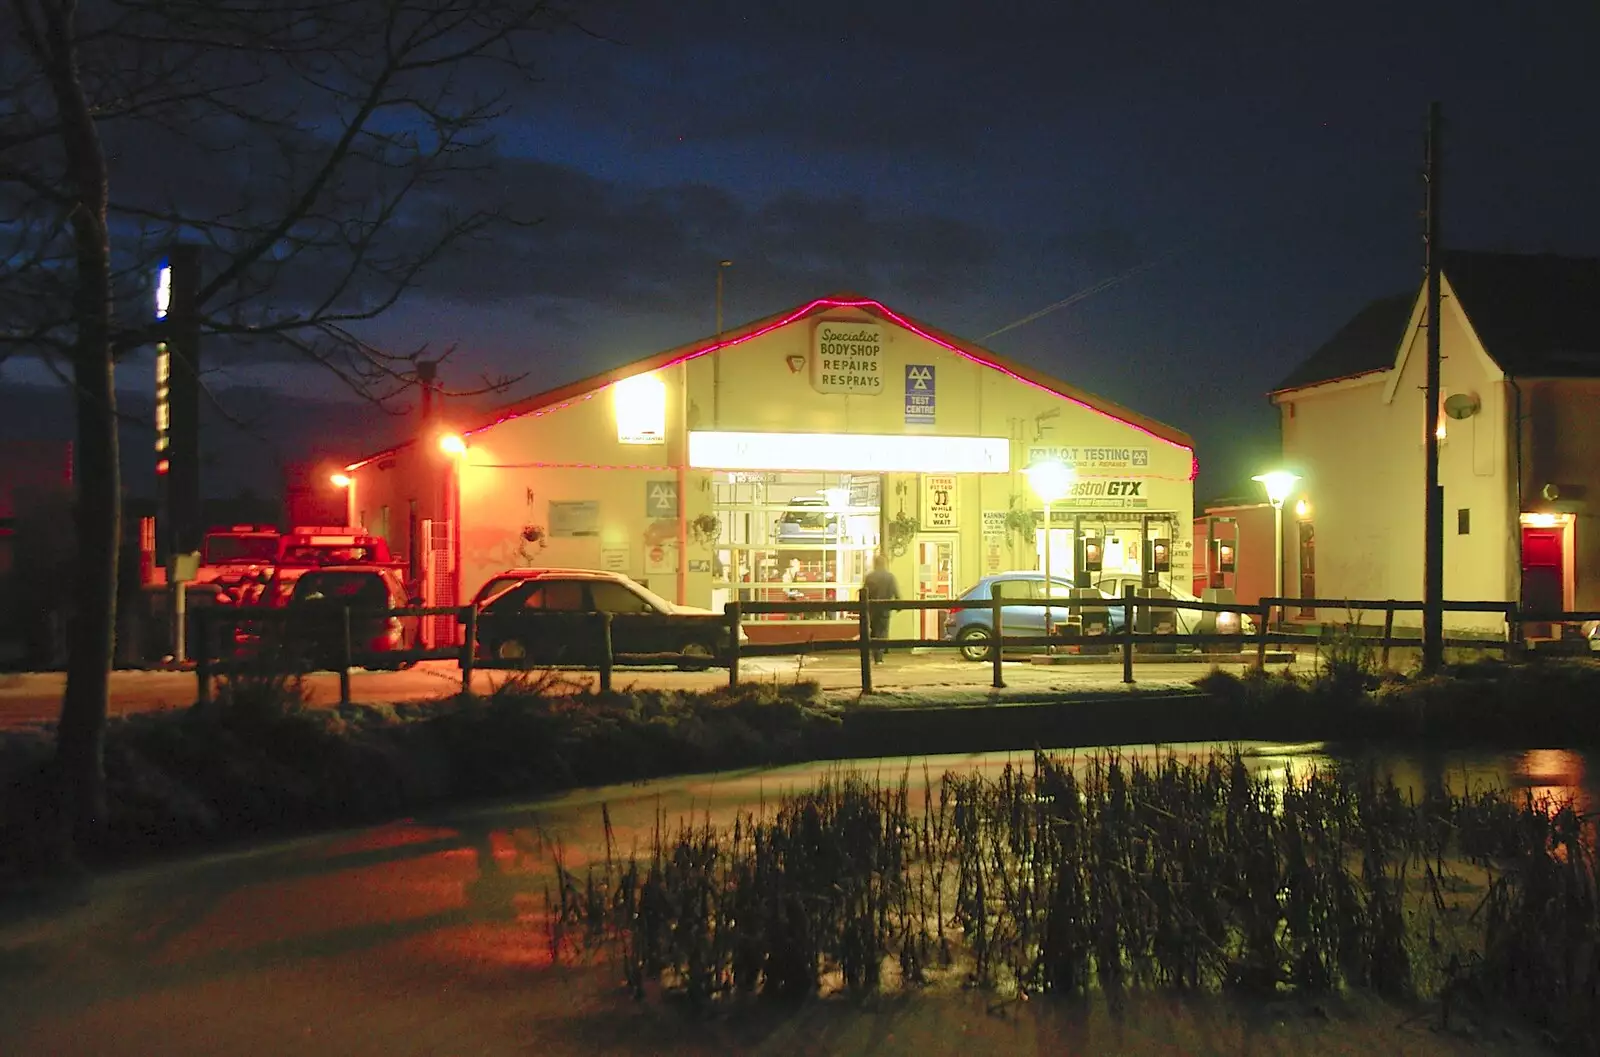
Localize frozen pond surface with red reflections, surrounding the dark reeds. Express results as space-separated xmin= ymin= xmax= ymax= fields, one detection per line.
xmin=0 ymin=747 xmax=1555 ymax=1057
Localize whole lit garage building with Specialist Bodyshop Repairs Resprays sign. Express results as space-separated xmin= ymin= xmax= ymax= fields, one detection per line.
xmin=344 ymin=294 xmax=1197 ymax=640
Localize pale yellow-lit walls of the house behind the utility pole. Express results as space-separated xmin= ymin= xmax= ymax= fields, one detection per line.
xmin=1278 ymin=279 xmax=1518 ymax=628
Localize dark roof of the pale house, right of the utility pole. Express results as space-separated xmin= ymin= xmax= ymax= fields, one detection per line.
xmin=1445 ymin=253 xmax=1600 ymax=377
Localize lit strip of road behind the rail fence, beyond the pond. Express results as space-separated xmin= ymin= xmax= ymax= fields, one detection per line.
xmin=0 ymin=652 xmax=1312 ymax=728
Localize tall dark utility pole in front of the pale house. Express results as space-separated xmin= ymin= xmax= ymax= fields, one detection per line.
xmin=1422 ymin=102 xmax=1445 ymax=673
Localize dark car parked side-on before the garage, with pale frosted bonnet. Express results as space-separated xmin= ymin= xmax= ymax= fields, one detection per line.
xmin=477 ymin=569 xmax=746 ymax=668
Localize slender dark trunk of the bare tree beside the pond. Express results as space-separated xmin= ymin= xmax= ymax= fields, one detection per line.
xmin=42 ymin=5 xmax=122 ymax=836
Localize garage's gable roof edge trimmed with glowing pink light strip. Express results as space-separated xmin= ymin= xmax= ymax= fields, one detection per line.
xmin=346 ymin=293 xmax=1194 ymax=470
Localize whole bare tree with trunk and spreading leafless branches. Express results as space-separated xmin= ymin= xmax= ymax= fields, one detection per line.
xmin=0 ymin=0 xmax=571 ymax=833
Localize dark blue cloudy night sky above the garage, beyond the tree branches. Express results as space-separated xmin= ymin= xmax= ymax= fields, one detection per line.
xmin=9 ymin=0 xmax=1600 ymax=499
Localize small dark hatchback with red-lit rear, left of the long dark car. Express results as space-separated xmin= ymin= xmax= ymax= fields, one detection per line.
xmin=240 ymin=566 xmax=416 ymax=670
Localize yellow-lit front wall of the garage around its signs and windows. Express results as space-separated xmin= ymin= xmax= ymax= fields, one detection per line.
xmin=357 ymin=300 xmax=1194 ymax=626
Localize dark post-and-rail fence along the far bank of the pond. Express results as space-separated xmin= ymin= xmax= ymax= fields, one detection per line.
xmin=195 ymin=587 xmax=1600 ymax=704
